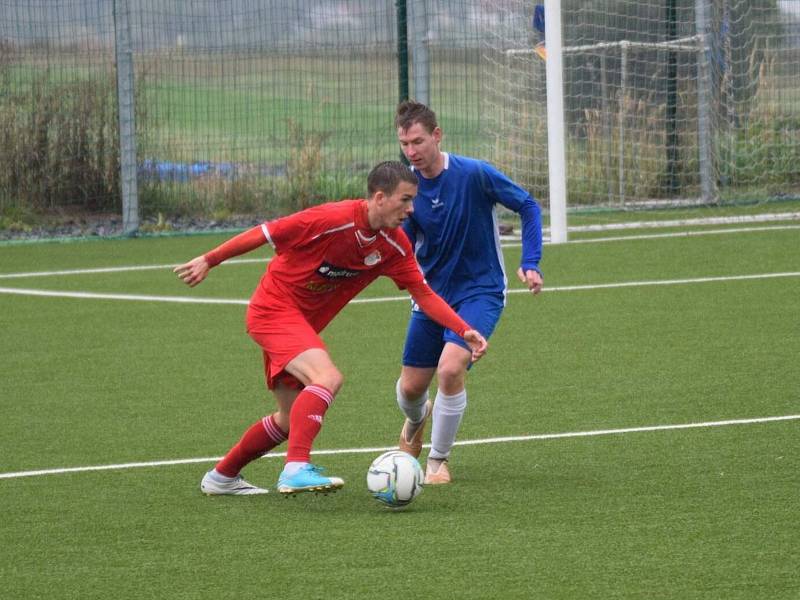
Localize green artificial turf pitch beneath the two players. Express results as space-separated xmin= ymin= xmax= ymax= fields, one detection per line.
xmin=0 ymin=208 xmax=800 ymax=600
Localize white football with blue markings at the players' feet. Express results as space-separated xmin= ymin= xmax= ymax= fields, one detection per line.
xmin=367 ymin=450 xmax=424 ymax=508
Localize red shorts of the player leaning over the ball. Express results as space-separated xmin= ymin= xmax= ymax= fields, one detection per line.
xmin=247 ymin=302 xmax=327 ymax=390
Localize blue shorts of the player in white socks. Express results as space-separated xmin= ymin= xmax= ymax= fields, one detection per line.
xmin=403 ymin=296 xmax=503 ymax=368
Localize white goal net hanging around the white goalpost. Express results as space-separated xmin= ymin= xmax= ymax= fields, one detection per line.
xmin=484 ymin=0 xmax=800 ymax=207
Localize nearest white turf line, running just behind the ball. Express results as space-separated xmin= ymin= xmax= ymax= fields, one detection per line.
xmin=0 ymin=415 xmax=800 ymax=479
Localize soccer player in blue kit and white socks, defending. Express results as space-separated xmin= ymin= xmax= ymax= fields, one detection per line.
xmin=395 ymin=100 xmax=543 ymax=484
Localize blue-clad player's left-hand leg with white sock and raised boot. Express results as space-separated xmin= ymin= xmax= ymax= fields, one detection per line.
xmin=396 ymin=367 xmax=436 ymax=458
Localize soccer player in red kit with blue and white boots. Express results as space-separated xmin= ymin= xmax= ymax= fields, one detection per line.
xmin=175 ymin=161 xmax=487 ymax=495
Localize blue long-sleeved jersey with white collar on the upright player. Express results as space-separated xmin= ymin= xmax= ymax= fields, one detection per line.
xmin=403 ymin=153 xmax=542 ymax=306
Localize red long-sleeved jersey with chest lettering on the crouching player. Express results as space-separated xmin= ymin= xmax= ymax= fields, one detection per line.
xmin=205 ymin=200 xmax=469 ymax=336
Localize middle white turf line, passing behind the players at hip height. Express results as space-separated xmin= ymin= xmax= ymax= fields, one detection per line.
xmin=0 ymin=271 xmax=800 ymax=305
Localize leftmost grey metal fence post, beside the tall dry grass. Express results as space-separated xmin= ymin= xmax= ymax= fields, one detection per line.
xmin=114 ymin=0 xmax=139 ymax=235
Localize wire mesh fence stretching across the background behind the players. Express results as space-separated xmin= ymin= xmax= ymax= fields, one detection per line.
xmin=0 ymin=0 xmax=800 ymax=232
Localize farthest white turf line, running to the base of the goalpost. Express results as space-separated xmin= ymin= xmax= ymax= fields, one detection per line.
xmin=0 ymin=223 xmax=800 ymax=279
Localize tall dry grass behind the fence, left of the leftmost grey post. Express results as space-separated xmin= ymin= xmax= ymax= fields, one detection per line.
xmin=0 ymin=72 xmax=120 ymax=211
